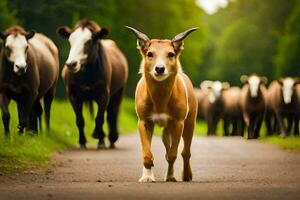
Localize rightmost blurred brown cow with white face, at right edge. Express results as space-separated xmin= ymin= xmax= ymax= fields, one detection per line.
xmin=267 ymin=77 xmax=300 ymax=137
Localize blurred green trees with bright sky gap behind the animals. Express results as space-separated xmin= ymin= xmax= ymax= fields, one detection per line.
xmin=0 ymin=0 xmax=300 ymax=98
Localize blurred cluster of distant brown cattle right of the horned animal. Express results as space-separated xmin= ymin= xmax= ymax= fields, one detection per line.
xmin=194 ymin=74 xmax=300 ymax=139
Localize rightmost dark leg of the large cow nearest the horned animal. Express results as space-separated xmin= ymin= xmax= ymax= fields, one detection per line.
xmin=107 ymin=88 xmax=123 ymax=148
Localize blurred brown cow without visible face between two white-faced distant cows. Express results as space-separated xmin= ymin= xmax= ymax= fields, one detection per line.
xmin=222 ymin=87 xmax=244 ymax=136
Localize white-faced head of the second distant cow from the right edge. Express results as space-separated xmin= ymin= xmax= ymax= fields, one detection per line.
xmin=240 ymin=74 xmax=268 ymax=98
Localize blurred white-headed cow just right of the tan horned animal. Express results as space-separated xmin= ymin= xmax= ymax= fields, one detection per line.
xmin=199 ymin=81 xmax=230 ymax=135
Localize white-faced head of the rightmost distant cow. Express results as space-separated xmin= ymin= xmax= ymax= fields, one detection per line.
xmin=277 ymin=77 xmax=300 ymax=104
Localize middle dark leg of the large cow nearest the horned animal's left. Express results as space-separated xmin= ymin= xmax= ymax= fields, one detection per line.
xmin=92 ymin=95 xmax=109 ymax=149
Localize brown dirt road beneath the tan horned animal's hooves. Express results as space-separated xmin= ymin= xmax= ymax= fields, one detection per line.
xmin=0 ymin=135 xmax=300 ymax=200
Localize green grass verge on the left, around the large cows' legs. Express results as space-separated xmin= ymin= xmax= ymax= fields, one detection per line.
xmin=0 ymin=99 xmax=137 ymax=173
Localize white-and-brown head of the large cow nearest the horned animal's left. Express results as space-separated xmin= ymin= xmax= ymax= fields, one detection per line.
xmin=56 ymin=19 xmax=109 ymax=73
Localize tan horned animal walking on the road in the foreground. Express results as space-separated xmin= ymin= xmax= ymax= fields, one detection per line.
xmin=127 ymin=27 xmax=197 ymax=182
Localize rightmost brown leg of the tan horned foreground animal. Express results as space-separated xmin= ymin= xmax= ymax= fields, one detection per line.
xmin=181 ymin=121 xmax=195 ymax=181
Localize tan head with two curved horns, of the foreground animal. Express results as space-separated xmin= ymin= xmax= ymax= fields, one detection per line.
xmin=126 ymin=26 xmax=197 ymax=81
